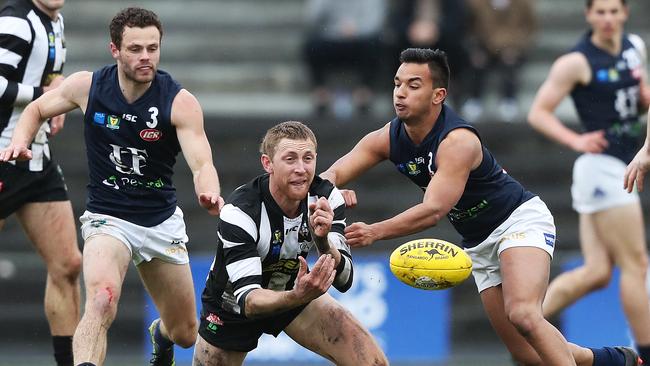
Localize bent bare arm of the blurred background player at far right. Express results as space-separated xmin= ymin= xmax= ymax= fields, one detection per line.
xmin=528 ymin=52 xmax=607 ymax=153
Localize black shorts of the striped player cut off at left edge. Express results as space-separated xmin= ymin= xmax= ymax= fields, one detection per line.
xmin=0 ymin=162 xmax=68 ymax=219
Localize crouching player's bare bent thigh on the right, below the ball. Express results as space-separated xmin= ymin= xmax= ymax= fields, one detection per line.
xmin=284 ymin=293 xmax=388 ymax=366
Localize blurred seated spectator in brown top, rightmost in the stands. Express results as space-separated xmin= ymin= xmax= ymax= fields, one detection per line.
xmin=461 ymin=0 xmax=536 ymax=122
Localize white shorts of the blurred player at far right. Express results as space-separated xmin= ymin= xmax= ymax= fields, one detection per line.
xmin=571 ymin=154 xmax=639 ymax=214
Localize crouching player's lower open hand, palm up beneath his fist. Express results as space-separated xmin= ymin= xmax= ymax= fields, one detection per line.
xmin=293 ymin=254 xmax=336 ymax=303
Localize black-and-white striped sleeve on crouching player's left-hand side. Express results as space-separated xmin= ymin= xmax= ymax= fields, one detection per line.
xmin=217 ymin=204 xmax=262 ymax=309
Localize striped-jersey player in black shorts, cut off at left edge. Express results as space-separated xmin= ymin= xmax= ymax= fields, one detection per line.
xmin=0 ymin=0 xmax=81 ymax=366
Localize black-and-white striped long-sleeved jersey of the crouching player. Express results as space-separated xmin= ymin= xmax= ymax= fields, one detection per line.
xmin=202 ymin=174 xmax=353 ymax=317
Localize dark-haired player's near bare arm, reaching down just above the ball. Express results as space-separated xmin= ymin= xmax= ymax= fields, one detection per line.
xmin=345 ymin=128 xmax=483 ymax=246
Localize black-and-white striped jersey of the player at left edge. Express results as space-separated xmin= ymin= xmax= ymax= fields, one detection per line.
xmin=0 ymin=0 xmax=66 ymax=171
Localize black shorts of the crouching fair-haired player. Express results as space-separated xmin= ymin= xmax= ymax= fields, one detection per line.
xmin=199 ymin=304 xmax=307 ymax=352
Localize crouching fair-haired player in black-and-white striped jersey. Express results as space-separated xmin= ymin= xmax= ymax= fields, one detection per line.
xmin=194 ymin=121 xmax=388 ymax=366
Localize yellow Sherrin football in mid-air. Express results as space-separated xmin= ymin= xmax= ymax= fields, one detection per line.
xmin=390 ymin=239 xmax=472 ymax=290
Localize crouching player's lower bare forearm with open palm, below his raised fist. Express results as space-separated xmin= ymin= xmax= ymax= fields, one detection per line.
xmin=245 ymin=254 xmax=336 ymax=318
